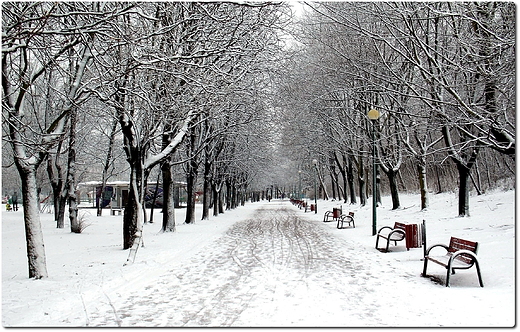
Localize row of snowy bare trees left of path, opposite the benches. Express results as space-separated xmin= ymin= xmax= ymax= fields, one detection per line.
xmin=2 ymin=2 xmax=290 ymax=279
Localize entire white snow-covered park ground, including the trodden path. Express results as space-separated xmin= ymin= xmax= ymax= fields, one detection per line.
xmin=2 ymin=191 xmax=516 ymax=327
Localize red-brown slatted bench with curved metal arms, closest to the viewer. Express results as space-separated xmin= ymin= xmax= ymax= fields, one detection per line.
xmin=422 ymin=237 xmax=484 ymax=287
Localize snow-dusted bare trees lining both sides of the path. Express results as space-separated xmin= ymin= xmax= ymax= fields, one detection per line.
xmin=2 ymin=2 xmax=516 ymax=278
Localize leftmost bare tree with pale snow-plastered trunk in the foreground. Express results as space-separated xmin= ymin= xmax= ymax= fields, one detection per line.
xmin=2 ymin=2 xmax=119 ymax=279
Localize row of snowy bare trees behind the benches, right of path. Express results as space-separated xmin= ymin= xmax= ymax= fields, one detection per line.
xmin=280 ymin=2 xmax=516 ymax=216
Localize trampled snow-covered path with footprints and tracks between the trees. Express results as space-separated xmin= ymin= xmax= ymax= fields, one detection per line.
xmin=85 ymin=202 xmax=394 ymax=326
